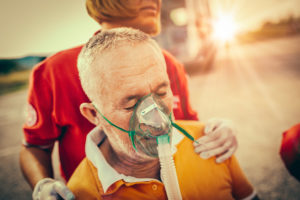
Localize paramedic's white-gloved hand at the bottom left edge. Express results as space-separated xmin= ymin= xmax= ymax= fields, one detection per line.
xmin=32 ymin=178 xmax=75 ymax=200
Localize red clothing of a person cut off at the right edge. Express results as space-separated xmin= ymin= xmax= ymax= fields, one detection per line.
xmin=280 ymin=124 xmax=300 ymax=181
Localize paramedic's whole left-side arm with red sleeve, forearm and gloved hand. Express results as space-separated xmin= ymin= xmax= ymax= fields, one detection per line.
xmin=20 ymin=60 xmax=74 ymax=200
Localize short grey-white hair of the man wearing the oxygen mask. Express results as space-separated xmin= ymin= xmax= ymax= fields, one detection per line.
xmin=77 ymin=28 xmax=163 ymax=104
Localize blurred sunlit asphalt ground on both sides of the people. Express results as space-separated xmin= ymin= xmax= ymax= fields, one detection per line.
xmin=0 ymin=36 xmax=300 ymax=200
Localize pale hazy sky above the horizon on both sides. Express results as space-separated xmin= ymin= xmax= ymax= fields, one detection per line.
xmin=0 ymin=0 xmax=300 ymax=58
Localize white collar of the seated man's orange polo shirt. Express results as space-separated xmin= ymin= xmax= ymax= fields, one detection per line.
xmin=85 ymin=127 xmax=184 ymax=193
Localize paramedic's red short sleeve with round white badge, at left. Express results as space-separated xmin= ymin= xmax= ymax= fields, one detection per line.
xmin=23 ymin=61 xmax=61 ymax=146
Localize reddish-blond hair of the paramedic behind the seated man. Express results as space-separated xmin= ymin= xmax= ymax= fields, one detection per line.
xmin=86 ymin=0 xmax=138 ymax=24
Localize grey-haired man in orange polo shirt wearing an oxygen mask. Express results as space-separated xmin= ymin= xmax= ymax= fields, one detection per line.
xmin=68 ymin=28 xmax=256 ymax=200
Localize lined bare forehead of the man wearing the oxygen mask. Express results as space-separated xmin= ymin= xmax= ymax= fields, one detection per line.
xmin=94 ymin=42 xmax=169 ymax=104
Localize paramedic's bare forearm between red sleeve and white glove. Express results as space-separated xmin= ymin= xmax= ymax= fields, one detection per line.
xmin=20 ymin=145 xmax=53 ymax=189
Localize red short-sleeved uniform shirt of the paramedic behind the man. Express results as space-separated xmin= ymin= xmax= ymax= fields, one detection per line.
xmin=23 ymin=46 xmax=197 ymax=180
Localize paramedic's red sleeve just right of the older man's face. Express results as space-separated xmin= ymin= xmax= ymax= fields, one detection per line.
xmin=163 ymin=50 xmax=198 ymax=120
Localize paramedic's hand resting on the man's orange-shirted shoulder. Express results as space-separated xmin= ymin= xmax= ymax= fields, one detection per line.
xmin=194 ymin=119 xmax=238 ymax=163
